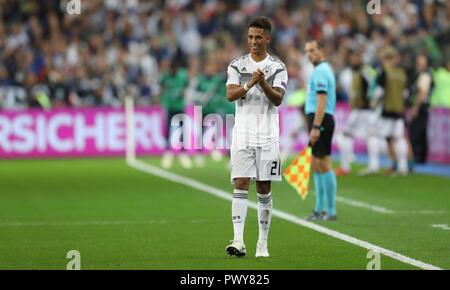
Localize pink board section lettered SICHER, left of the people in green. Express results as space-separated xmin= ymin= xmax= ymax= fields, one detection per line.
xmin=0 ymin=107 xmax=165 ymax=158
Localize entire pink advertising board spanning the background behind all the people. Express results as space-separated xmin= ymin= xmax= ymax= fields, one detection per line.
xmin=0 ymin=104 xmax=450 ymax=164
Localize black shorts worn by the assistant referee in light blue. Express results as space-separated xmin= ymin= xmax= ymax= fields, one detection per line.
xmin=306 ymin=114 xmax=334 ymax=158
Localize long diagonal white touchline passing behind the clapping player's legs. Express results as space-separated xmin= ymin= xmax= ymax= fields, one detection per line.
xmin=127 ymin=158 xmax=442 ymax=270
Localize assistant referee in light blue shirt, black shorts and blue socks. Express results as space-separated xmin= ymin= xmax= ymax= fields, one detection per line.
xmin=305 ymin=40 xmax=337 ymax=221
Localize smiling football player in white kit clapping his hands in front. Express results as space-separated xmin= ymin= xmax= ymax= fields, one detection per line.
xmin=226 ymin=17 xmax=288 ymax=257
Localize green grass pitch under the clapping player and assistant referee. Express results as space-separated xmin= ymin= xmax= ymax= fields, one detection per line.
xmin=0 ymin=158 xmax=450 ymax=270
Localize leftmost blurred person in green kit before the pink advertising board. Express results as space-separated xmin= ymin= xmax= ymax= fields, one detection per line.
xmin=160 ymin=60 xmax=192 ymax=169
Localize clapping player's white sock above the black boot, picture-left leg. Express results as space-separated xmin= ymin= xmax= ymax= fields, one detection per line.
xmin=231 ymin=189 xmax=248 ymax=242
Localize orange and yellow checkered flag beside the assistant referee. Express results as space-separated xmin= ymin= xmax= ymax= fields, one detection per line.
xmin=283 ymin=146 xmax=312 ymax=199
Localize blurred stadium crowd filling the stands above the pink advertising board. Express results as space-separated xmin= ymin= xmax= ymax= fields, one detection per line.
xmin=0 ymin=0 xmax=450 ymax=110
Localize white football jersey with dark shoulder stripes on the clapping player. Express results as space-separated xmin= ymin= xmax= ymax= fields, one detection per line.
xmin=227 ymin=54 xmax=288 ymax=148
